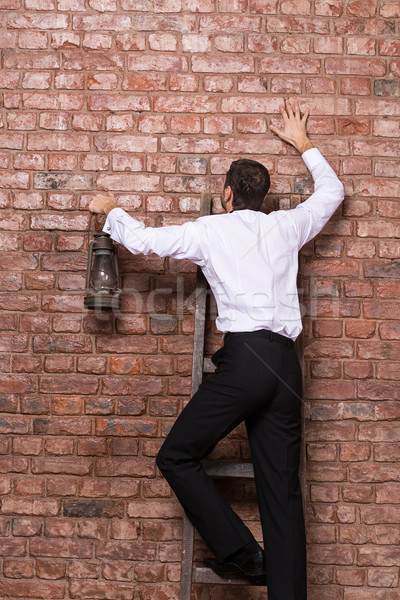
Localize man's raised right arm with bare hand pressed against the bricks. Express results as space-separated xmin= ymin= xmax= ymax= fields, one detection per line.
xmin=270 ymin=101 xmax=344 ymax=249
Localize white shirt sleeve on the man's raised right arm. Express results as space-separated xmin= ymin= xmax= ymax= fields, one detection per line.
xmin=287 ymin=148 xmax=344 ymax=249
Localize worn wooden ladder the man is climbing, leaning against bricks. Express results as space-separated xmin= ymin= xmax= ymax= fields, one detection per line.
xmin=179 ymin=194 xmax=304 ymax=600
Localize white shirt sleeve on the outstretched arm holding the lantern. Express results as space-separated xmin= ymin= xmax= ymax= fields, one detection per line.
xmin=103 ymin=208 xmax=205 ymax=266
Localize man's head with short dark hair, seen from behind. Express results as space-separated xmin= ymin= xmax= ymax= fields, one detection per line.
xmin=224 ymin=158 xmax=270 ymax=210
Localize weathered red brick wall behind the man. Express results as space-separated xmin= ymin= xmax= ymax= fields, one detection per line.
xmin=0 ymin=0 xmax=400 ymax=600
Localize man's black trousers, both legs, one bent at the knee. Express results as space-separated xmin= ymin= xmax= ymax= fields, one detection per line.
xmin=157 ymin=329 xmax=307 ymax=600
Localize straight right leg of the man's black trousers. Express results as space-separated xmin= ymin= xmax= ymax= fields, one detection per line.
xmin=246 ymin=348 xmax=307 ymax=600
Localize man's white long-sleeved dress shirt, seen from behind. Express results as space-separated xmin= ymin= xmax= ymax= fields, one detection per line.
xmin=103 ymin=148 xmax=344 ymax=340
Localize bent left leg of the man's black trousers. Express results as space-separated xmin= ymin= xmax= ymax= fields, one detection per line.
xmin=157 ymin=338 xmax=279 ymax=559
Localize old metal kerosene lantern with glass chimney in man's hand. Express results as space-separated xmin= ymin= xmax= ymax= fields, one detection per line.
xmin=84 ymin=224 xmax=121 ymax=311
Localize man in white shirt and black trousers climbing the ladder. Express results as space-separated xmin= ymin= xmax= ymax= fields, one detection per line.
xmin=89 ymin=101 xmax=343 ymax=600
